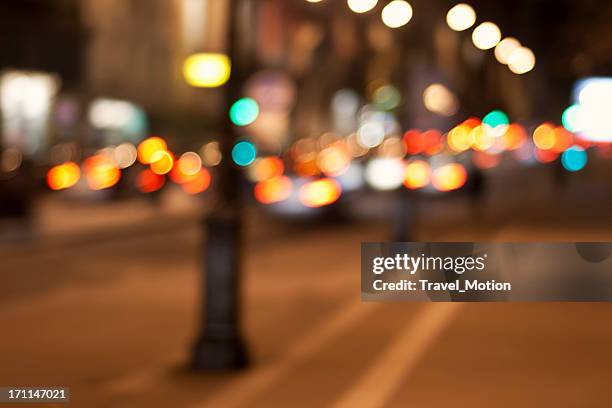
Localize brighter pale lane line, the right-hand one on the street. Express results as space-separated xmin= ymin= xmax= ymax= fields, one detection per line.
xmin=332 ymin=302 xmax=462 ymax=408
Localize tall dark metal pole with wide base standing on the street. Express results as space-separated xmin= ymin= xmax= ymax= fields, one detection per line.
xmin=192 ymin=0 xmax=248 ymax=370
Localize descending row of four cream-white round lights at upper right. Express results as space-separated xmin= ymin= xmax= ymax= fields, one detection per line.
xmin=446 ymin=3 xmax=535 ymax=75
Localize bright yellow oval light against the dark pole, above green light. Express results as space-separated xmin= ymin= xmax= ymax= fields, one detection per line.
xmin=183 ymin=53 xmax=231 ymax=88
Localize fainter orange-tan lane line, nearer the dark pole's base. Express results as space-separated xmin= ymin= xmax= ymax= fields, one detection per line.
xmin=193 ymin=301 xmax=381 ymax=408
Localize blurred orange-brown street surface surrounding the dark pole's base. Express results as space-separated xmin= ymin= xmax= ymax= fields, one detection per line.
xmin=0 ymin=176 xmax=612 ymax=407
